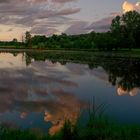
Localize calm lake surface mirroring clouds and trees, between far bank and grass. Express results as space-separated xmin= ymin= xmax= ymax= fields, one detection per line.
xmin=0 ymin=51 xmax=140 ymax=133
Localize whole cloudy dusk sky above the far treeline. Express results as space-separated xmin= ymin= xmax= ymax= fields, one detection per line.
xmin=0 ymin=0 xmax=140 ymax=40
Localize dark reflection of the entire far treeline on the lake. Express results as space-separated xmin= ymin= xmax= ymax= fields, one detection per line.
xmin=23 ymin=51 xmax=140 ymax=92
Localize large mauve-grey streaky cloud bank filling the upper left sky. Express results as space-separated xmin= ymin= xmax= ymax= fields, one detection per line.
xmin=0 ymin=0 xmax=80 ymax=35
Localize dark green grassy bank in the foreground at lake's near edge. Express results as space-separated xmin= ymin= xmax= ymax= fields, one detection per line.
xmin=0 ymin=110 xmax=140 ymax=140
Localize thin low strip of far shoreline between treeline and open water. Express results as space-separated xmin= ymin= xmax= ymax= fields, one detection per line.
xmin=0 ymin=48 xmax=140 ymax=58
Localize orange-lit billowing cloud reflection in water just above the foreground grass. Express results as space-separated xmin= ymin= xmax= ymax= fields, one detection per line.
xmin=44 ymin=89 xmax=83 ymax=134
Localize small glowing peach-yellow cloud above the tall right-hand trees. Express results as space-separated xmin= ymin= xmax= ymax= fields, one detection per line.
xmin=122 ymin=1 xmax=140 ymax=13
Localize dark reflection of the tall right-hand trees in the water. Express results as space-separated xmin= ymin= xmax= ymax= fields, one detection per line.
xmin=102 ymin=58 xmax=140 ymax=95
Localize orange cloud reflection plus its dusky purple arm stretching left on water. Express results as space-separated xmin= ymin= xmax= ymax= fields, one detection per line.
xmin=17 ymin=89 xmax=86 ymax=134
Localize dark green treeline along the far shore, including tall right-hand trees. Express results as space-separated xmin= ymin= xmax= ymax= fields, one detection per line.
xmin=0 ymin=11 xmax=140 ymax=50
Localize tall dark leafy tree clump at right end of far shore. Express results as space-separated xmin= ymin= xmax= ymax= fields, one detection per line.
xmin=111 ymin=11 xmax=140 ymax=48
